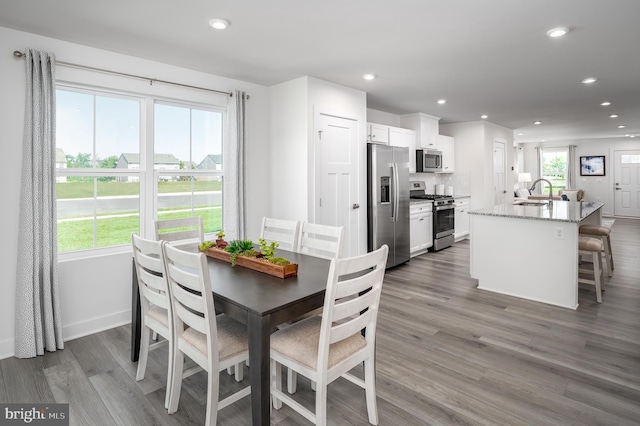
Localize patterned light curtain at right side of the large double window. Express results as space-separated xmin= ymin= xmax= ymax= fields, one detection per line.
xmin=223 ymin=90 xmax=247 ymax=240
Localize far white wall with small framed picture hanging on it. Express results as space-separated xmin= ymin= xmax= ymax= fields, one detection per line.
xmin=521 ymin=138 xmax=640 ymax=216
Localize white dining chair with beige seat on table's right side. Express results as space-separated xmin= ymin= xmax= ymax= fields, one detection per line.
xmin=271 ymin=245 xmax=389 ymax=426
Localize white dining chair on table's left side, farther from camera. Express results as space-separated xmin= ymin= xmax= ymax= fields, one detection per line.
xmin=131 ymin=234 xmax=173 ymax=408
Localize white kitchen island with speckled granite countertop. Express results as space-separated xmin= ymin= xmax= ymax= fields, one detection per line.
xmin=469 ymin=201 xmax=604 ymax=309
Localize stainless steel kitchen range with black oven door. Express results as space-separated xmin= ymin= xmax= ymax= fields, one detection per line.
xmin=409 ymin=181 xmax=456 ymax=251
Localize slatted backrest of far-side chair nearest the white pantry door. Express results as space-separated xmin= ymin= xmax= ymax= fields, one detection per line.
xmin=296 ymin=222 xmax=344 ymax=259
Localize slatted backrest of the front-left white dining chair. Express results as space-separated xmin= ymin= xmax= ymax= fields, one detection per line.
xmin=162 ymin=242 xmax=218 ymax=371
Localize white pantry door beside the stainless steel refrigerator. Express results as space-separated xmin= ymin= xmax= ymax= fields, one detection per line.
xmin=314 ymin=113 xmax=366 ymax=257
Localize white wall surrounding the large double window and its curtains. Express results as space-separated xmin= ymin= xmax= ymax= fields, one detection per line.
xmin=0 ymin=27 xmax=270 ymax=358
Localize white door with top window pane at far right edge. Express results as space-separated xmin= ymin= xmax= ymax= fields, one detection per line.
xmin=613 ymin=149 xmax=640 ymax=217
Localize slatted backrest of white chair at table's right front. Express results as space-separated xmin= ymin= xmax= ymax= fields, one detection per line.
xmin=318 ymin=244 xmax=389 ymax=371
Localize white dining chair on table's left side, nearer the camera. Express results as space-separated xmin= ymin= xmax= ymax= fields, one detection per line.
xmin=162 ymin=242 xmax=251 ymax=425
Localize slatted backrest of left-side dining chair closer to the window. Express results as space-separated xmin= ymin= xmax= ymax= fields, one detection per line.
xmin=131 ymin=234 xmax=171 ymax=318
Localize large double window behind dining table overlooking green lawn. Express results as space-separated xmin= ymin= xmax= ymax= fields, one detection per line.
xmin=56 ymin=86 xmax=225 ymax=253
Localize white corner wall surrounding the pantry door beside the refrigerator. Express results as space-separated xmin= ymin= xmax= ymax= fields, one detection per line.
xmin=269 ymin=77 xmax=367 ymax=253
